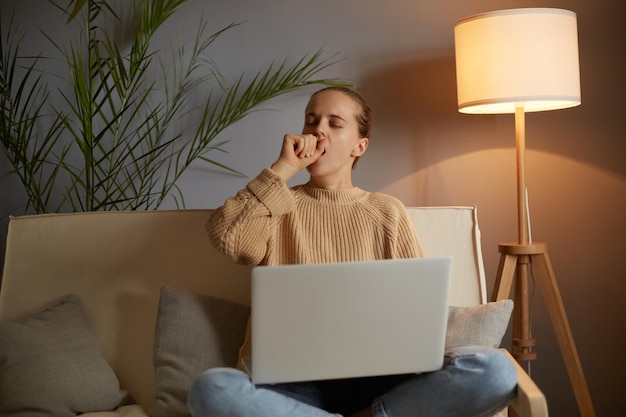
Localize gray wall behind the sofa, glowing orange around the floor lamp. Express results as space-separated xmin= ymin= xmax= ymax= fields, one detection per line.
xmin=0 ymin=0 xmax=626 ymax=417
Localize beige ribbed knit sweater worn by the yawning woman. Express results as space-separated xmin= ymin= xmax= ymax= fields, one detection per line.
xmin=206 ymin=168 xmax=423 ymax=368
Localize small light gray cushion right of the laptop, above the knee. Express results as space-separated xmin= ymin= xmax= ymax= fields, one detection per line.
xmin=446 ymin=300 xmax=513 ymax=348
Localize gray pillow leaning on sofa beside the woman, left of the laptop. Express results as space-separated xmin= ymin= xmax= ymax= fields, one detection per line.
xmin=150 ymin=288 xmax=250 ymax=417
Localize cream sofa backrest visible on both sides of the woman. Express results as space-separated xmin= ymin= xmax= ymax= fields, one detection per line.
xmin=0 ymin=207 xmax=485 ymax=410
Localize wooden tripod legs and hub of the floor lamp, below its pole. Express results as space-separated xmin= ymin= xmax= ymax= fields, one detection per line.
xmin=492 ymin=243 xmax=595 ymax=417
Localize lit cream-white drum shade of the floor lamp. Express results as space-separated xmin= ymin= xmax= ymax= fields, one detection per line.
xmin=454 ymin=8 xmax=580 ymax=114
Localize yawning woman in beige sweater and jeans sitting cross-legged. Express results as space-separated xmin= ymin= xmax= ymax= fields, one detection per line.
xmin=188 ymin=87 xmax=516 ymax=417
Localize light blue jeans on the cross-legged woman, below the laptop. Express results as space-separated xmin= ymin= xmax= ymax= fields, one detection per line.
xmin=188 ymin=346 xmax=517 ymax=417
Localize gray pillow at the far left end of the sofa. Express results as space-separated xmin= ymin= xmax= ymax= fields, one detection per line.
xmin=0 ymin=295 xmax=127 ymax=417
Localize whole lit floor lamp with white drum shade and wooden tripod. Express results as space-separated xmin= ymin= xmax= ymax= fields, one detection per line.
xmin=454 ymin=8 xmax=595 ymax=417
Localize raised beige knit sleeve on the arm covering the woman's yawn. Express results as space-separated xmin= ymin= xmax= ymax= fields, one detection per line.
xmin=206 ymin=168 xmax=295 ymax=265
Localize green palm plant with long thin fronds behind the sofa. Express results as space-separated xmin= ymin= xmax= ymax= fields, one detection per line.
xmin=0 ymin=0 xmax=345 ymax=213
